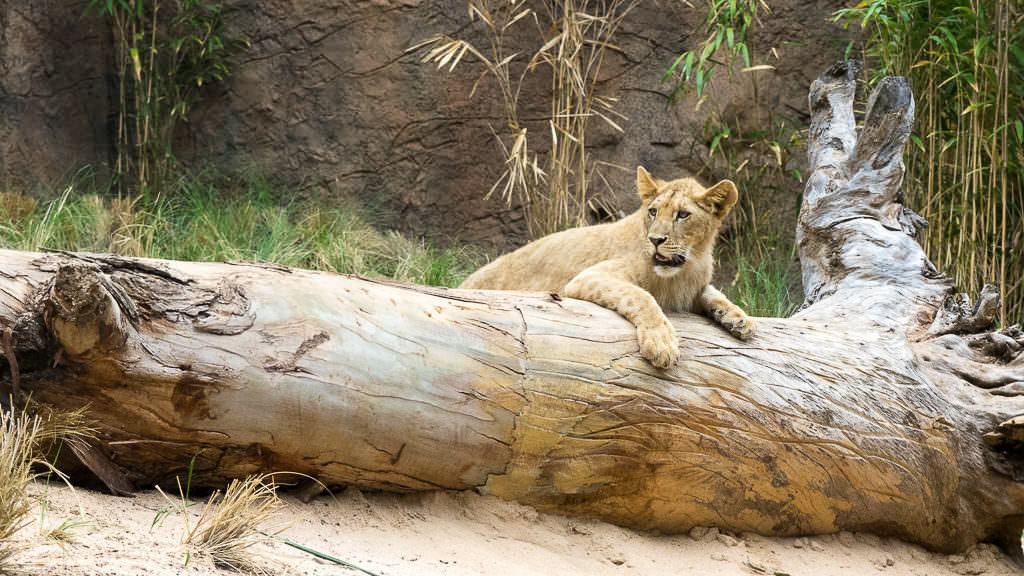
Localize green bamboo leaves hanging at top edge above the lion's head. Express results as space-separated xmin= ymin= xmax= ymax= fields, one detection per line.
xmin=662 ymin=0 xmax=771 ymax=99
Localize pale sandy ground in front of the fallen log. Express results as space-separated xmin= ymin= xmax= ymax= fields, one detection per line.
xmin=9 ymin=485 xmax=1024 ymax=576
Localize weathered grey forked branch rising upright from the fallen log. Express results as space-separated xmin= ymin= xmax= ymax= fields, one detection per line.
xmin=797 ymin=61 xmax=949 ymax=330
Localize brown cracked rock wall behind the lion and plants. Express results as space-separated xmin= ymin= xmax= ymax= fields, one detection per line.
xmin=0 ymin=0 xmax=845 ymax=251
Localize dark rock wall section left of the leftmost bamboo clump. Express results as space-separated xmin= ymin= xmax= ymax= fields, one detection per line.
xmin=0 ymin=0 xmax=117 ymax=192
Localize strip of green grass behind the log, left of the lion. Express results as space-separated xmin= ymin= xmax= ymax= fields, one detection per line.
xmin=0 ymin=174 xmax=479 ymax=286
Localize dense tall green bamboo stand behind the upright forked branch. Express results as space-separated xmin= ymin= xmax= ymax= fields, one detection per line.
xmin=835 ymin=0 xmax=1024 ymax=325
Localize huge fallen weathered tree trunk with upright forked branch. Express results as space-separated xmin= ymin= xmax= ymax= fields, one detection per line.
xmin=0 ymin=64 xmax=1024 ymax=550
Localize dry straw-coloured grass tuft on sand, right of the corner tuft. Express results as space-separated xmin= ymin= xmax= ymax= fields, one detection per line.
xmin=181 ymin=475 xmax=282 ymax=573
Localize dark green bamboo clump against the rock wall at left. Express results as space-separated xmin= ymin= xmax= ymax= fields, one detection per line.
xmin=89 ymin=0 xmax=247 ymax=192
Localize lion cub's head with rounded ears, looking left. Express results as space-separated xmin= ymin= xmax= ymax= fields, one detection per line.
xmin=637 ymin=166 xmax=738 ymax=278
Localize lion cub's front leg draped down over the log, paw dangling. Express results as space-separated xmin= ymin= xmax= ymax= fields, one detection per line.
xmin=564 ymin=261 xmax=679 ymax=368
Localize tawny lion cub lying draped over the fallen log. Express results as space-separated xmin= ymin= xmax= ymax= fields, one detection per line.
xmin=460 ymin=166 xmax=754 ymax=368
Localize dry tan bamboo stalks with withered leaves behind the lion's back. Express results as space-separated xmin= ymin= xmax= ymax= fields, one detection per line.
xmin=410 ymin=0 xmax=638 ymax=238
